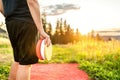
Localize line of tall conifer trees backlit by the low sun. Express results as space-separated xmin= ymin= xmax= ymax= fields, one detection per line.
xmin=42 ymin=15 xmax=81 ymax=44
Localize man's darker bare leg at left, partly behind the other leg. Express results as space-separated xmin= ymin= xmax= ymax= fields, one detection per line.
xmin=8 ymin=62 xmax=19 ymax=80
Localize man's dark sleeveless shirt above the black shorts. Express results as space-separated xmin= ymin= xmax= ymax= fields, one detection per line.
xmin=2 ymin=0 xmax=34 ymax=23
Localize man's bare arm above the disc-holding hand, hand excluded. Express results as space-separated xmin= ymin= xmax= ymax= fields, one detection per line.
xmin=27 ymin=0 xmax=44 ymax=33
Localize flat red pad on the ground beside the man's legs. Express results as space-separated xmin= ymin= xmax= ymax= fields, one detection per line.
xmin=31 ymin=64 xmax=89 ymax=80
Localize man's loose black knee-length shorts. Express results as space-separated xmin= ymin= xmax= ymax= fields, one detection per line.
xmin=6 ymin=20 xmax=38 ymax=65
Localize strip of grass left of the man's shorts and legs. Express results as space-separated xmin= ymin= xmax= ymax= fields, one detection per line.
xmin=0 ymin=38 xmax=13 ymax=80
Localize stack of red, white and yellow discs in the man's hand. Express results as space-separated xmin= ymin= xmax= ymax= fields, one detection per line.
xmin=36 ymin=39 xmax=52 ymax=60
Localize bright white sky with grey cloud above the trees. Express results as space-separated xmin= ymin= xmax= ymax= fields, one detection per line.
xmin=0 ymin=0 xmax=120 ymax=34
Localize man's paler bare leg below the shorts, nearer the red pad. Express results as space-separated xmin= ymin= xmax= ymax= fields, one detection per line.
xmin=16 ymin=65 xmax=31 ymax=80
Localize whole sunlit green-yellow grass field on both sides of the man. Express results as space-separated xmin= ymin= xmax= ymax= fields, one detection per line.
xmin=0 ymin=38 xmax=120 ymax=80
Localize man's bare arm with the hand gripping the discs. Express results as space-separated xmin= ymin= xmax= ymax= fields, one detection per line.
xmin=27 ymin=0 xmax=51 ymax=46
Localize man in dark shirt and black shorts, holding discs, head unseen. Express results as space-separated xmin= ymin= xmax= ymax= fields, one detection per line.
xmin=0 ymin=0 xmax=51 ymax=80
